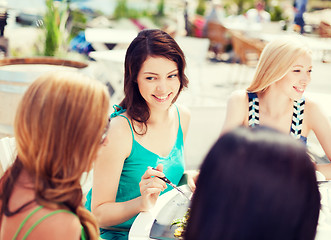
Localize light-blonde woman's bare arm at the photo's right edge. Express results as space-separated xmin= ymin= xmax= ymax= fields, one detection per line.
xmin=305 ymin=100 xmax=331 ymax=179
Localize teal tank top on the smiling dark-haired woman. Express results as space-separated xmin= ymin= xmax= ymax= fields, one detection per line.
xmin=85 ymin=105 xmax=185 ymax=239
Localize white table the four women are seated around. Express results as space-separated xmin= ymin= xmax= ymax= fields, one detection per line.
xmin=129 ymin=183 xmax=331 ymax=240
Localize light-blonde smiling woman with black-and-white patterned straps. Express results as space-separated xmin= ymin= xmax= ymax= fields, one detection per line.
xmin=221 ymin=37 xmax=331 ymax=179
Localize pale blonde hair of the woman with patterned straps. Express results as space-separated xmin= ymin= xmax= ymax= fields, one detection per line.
xmin=247 ymin=36 xmax=312 ymax=92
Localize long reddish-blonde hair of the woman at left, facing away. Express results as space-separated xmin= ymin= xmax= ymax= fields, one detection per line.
xmin=1 ymin=72 xmax=109 ymax=239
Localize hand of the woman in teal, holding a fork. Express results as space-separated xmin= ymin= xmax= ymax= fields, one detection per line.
xmin=139 ymin=164 xmax=167 ymax=211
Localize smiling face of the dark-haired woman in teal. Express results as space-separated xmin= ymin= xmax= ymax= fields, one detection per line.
xmin=137 ymin=57 xmax=180 ymax=109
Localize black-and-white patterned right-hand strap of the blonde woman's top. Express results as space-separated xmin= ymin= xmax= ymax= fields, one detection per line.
xmin=290 ymin=98 xmax=305 ymax=139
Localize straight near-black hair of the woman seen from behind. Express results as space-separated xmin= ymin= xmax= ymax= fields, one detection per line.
xmin=185 ymin=127 xmax=320 ymax=240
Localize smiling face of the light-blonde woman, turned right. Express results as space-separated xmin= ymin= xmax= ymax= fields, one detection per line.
xmin=275 ymin=54 xmax=312 ymax=100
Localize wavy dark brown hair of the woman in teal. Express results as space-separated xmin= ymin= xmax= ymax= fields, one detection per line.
xmin=120 ymin=29 xmax=188 ymax=134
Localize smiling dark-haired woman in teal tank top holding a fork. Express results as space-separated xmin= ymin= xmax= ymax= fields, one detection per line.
xmin=86 ymin=30 xmax=194 ymax=239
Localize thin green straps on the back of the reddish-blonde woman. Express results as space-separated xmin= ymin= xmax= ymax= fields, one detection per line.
xmin=13 ymin=206 xmax=87 ymax=240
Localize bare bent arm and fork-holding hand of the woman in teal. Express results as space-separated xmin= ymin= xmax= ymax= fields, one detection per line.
xmin=91 ymin=117 xmax=166 ymax=227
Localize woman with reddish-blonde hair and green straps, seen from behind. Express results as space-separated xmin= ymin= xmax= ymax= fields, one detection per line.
xmin=0 ymin=72 xmax=109 ymax=240
